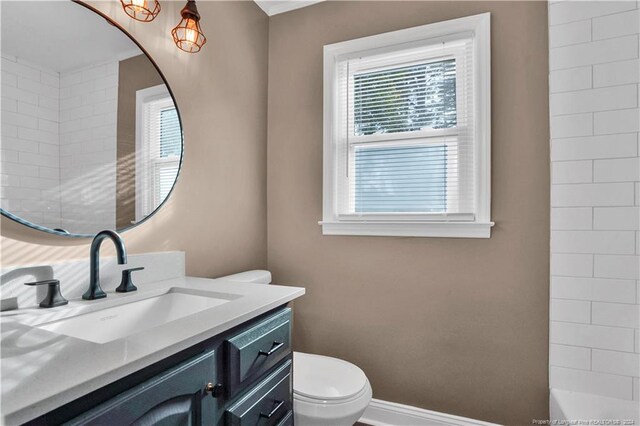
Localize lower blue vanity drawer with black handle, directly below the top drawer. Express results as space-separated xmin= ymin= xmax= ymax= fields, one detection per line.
xmin=225 ymin=360 xmax=293 ymax=426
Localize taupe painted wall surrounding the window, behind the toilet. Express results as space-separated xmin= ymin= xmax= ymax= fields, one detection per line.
xmin=267 ymin=2 xmax=549 ymax=424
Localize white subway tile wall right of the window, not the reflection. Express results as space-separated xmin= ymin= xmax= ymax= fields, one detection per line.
xmin=549 ymin=1 xmax=640 ymax=400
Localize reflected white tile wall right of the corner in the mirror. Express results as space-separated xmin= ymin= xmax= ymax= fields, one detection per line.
xmin=60 ymin=61 xmax=118 ymax=233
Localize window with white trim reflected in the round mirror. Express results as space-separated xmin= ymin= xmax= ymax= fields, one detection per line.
xmin=136 ymin=84 xmax=182 ymax=222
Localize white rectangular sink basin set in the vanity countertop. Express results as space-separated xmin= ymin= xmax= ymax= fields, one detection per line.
xmin=38 ymin=289 xmax=233 ymax=343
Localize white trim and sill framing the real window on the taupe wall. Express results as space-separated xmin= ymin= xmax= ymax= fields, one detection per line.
xmin=319 ymin=13 xmax=494 ymax=238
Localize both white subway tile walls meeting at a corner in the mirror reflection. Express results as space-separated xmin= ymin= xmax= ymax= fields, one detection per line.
xmin=0 ymin=54 xmax=118 ymax=233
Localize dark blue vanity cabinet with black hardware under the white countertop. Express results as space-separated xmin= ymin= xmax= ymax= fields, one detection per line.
xmin=28 ymin=307 xmax=293 ymax=426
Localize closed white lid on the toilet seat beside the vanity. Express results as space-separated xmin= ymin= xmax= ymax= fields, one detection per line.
xmin=293 ymin=352 xmax=367 ymax=400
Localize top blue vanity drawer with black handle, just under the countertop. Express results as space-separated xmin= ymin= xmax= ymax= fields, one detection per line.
xmin=225 ymin=308 xmax=291 ymax=397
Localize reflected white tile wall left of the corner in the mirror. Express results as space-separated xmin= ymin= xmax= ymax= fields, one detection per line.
xmin=0 ymin=54 xmax=61 ymax=228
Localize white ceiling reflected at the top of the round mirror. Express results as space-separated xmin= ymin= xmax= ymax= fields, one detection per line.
xmin=0 ymin=1 xmax=142 ymax=72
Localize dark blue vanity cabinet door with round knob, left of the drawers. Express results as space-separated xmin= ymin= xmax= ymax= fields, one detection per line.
xmin=67 ymin=351 xmax=219 ymax=426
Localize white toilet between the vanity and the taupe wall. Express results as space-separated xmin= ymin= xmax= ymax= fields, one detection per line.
xmin=220 ymin=270 xmax=372 ymax=426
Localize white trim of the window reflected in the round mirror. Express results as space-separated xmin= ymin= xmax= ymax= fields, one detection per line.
xmin=134 ymin=84 xmax=171 ymax=223
